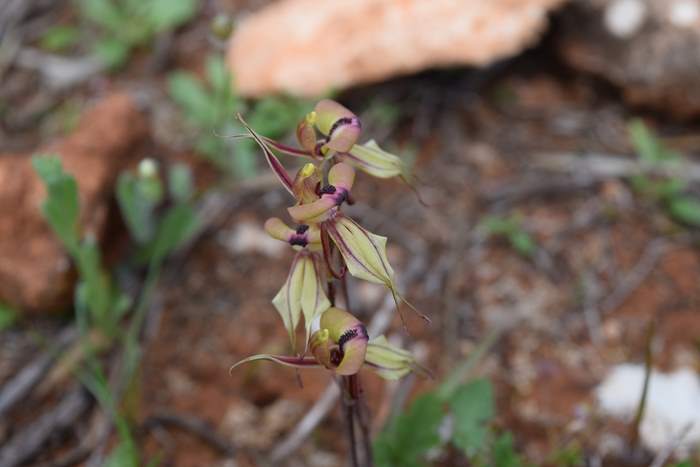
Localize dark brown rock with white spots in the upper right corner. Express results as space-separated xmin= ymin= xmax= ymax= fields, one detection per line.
xmin=557 ymin=0 xmax=700 ymax=118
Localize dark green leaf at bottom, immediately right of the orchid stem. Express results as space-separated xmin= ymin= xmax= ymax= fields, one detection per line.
xmin=374 ymin=393 xmax=445 ymax=467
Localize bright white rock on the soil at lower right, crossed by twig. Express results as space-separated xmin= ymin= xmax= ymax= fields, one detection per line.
xmin=596 ymin=364 xmax=700 ymax=458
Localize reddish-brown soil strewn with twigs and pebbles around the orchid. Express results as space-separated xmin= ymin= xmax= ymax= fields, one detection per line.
xmin=0 ymin=1 xmax=700 ymax=467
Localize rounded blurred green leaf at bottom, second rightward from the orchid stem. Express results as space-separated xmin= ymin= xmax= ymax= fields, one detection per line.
xmin=450 ymin=379 xmax=494 ymax=457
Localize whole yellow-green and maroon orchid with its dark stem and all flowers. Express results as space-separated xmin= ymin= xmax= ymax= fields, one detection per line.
xmin=232 ymin=100 xmax=429 ymax=465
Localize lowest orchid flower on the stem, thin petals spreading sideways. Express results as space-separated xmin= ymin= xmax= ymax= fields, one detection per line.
xmin=231 ymin=307 xmax=430 ymax=380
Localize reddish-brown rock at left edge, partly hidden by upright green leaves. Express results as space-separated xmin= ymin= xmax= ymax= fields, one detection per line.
xmin=0 ymin=94 xmax=147 ymax=311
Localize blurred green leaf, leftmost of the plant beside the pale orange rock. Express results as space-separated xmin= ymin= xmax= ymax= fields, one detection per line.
xmin=168 ymin=71 xmax=218 ymax=126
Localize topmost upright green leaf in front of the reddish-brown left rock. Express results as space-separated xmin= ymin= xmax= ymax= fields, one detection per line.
xmin=32 ymin=156 xmax=80 ymax=255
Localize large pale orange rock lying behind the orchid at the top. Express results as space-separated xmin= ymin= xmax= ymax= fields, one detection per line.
xmin=228 ymin=0 xmax=565 ymax=96
